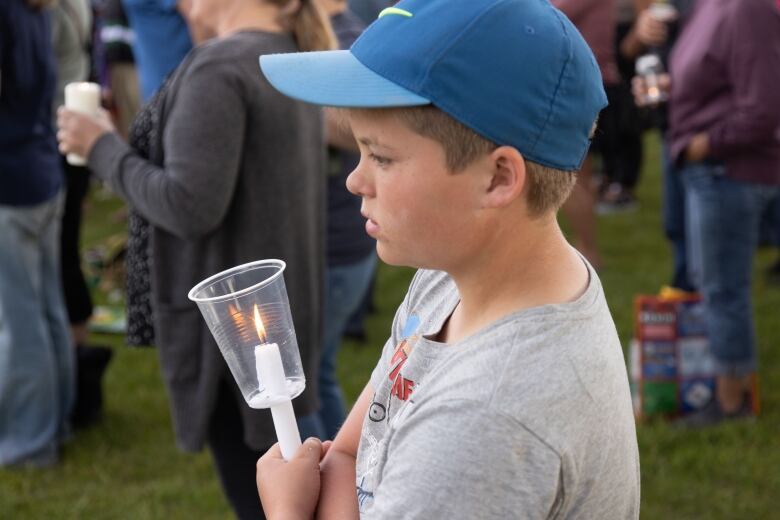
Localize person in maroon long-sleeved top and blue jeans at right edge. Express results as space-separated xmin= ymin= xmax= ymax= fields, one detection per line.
xmin=669 ymin=0 xmax=780 ymax=427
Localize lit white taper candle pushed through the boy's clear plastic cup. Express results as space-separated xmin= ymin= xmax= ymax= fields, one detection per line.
xmin=255 ymin=343 xmax=301 ymax=460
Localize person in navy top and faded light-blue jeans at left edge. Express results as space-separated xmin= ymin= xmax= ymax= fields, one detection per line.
xmin=0 ymin=0 xmax=74 ymax=467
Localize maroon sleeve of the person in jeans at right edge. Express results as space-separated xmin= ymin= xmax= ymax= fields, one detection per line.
xmin=708 ymin=0 xmax=780 ymax=158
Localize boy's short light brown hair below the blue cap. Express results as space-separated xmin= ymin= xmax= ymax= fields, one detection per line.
xmin=350 ymin=105 xmax=577 ymax=218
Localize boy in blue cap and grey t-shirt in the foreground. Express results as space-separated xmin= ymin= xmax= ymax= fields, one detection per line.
xmin=257 ymin=0 xmax=639 ymax=519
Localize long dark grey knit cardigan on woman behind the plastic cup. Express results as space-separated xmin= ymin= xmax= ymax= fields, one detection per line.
xmin=89 ymin=31 xmax=325 ymax=451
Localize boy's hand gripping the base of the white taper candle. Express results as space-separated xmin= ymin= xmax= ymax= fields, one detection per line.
xmin=257 ymin=437 xmax=330 ymax=520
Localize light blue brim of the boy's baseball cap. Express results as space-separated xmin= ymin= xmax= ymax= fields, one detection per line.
xmin=260 ymin=51 xmax=430 ymax=108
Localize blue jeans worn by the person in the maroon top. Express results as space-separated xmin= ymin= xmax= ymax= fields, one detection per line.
xmin=682 ymin=163 xmax=778 ymax=376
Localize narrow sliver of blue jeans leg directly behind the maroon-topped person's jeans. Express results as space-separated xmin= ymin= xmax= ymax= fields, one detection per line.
xmin=661 ymin=139 xmax=695 ymax=292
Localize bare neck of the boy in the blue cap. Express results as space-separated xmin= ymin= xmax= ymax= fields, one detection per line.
xmin=437 ymin=219 xmax=589 ymax=343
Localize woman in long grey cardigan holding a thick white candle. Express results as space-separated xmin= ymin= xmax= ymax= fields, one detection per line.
xmin=58 ymin=0 xmax=333 ymax=518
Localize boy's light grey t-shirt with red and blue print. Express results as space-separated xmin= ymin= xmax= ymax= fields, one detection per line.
xmin=356 ymin=267 xmax=639 ymax=519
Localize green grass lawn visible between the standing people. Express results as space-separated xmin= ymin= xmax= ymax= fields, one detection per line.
xmin=0 ymin=136 xmax=780 ymax=519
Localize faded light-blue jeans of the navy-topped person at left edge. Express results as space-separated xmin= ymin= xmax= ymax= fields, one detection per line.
xmin=0 ymin=196 xmax=75 ymax=466
